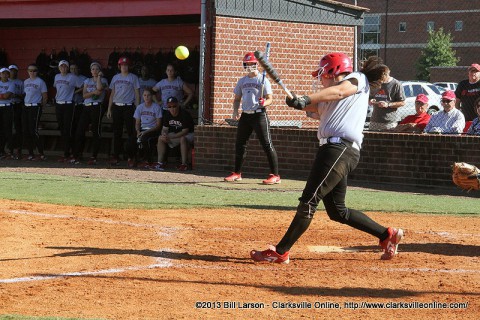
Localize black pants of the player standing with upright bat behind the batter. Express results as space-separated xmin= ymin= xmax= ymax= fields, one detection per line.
xmin=235 ymin=112 xmax=278 ymax=175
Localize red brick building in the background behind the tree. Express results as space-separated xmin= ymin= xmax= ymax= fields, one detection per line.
xmin=342 ymin=0 xmax=480 ymax=82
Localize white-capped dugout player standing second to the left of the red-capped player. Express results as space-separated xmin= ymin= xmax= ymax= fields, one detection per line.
xmin=53 ymin=60 xmax=83 ymax=163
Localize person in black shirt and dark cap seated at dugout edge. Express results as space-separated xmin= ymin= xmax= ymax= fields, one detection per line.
xmin=155 ymin=97 xmax=194 ymax=171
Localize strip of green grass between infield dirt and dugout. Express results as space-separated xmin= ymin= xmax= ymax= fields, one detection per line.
xmin=0 ymin=172 xmax=480 ymax=214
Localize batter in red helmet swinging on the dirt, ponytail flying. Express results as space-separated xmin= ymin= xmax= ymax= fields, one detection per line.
xmin=250 ymin=53 xmax=403 ymax=263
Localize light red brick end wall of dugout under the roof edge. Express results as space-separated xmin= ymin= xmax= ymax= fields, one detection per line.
xmin=210 ymin=16 xmax=354 ymax=128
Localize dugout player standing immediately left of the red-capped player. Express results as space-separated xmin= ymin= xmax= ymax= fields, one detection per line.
xmin=73 ymin=62 xmax=108 ymax=165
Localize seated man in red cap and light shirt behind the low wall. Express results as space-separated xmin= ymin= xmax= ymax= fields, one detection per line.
xmin=425 ymin=90 xmax=465 ymax=134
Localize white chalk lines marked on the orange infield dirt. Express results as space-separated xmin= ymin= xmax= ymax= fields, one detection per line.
xmin=0 ymin=210 xmax=480 ymax=284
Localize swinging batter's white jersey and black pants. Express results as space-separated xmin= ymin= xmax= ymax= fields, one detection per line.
xmin=276 ymin=72 xmax=386 ymax=254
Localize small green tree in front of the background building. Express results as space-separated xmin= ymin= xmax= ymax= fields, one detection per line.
xmin=416 ymin=28 xmax=460 ymax=81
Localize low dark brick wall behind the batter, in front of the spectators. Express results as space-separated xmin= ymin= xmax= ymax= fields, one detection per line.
xmin=195 ymin=126 xmax=480 ymax=186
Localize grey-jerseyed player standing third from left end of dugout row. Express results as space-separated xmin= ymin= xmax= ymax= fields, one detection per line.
xmin=22 ymin=64 xmax=48 ymax=161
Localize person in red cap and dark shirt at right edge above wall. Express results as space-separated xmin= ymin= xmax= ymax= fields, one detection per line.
xmin=455 ymin=63 xmax=480 ymax=121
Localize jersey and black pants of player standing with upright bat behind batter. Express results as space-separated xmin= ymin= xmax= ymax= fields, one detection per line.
xmin=233 ymin=73 xmax=278 ymax=176
